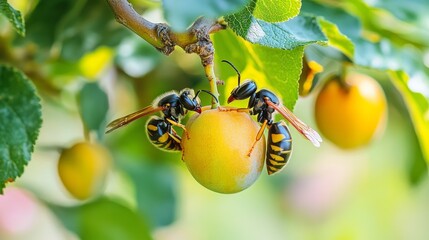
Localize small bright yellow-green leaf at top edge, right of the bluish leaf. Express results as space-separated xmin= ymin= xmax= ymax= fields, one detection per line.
xmin=253 ymin=0 xmax=301 ymax=22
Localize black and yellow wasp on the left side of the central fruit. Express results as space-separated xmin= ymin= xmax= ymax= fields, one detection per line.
xmin=106 ymin=88 xmax=218 ymax=151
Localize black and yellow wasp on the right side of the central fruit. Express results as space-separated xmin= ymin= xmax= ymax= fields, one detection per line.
xmin=222 ymin=60 xmax=322 ymax=175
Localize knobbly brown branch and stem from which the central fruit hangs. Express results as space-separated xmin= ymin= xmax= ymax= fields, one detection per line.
xmin=107 ymin=0 xmax=226 ymax=108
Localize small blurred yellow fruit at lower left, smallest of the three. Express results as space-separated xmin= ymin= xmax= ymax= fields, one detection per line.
xmin=58 ymin=142 xmax=111 ymax=200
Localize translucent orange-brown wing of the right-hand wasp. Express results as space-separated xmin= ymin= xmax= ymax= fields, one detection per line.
xmin=264 ymin=99 xmax=322 ymax=147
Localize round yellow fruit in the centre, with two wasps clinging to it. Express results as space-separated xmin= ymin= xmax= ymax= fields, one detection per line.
xmin=182 ymin=109 xmax=265 ymax=193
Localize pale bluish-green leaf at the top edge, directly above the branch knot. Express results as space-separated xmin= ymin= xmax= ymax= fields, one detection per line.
xmin=162 ymin=0 xmax=249 ymax=31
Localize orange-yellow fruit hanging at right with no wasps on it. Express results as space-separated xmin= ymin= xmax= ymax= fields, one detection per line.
xmin=315 ymin=73 xmax=387 ymax=149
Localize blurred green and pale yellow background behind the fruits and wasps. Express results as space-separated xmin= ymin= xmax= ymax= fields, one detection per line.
xmin=0 ymin=0 xmax=429 ymax=240
